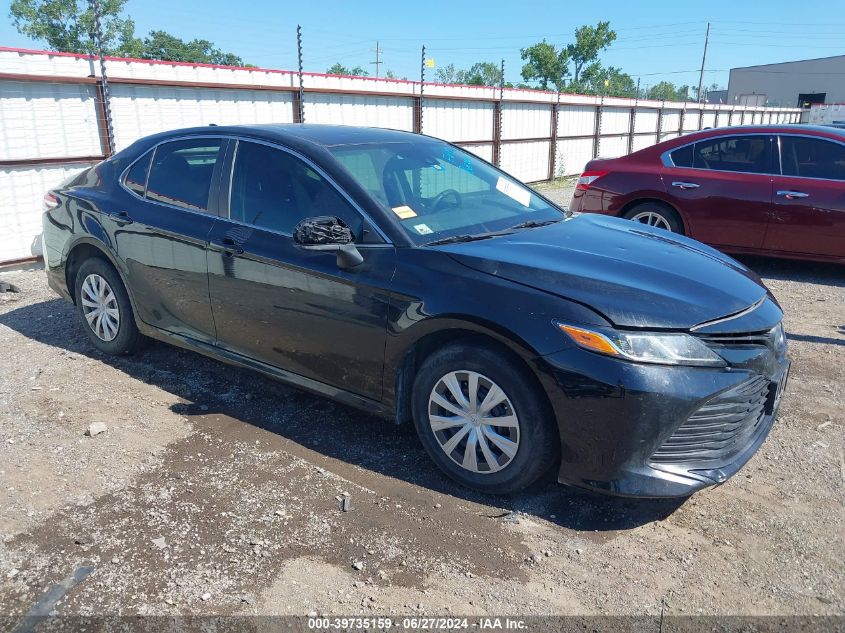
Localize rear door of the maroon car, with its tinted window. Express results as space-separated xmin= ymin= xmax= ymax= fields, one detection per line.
xmin=662 ymin=134 xmax=773 ymax=249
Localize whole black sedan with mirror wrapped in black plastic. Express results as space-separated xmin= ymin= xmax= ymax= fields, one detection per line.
xmin=44 ymin=125 xmax=789 ymax=496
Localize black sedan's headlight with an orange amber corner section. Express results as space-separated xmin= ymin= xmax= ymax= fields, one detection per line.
xmin=555 ymin=323 xmax=727 ymax=367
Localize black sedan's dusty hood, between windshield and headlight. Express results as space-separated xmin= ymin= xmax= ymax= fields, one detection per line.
xmin=439 ymin=214 xmax=767 ymax=329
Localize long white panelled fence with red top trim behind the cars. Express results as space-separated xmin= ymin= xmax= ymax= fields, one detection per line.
xmin=0 ymin=47 xmax=800 ymax=263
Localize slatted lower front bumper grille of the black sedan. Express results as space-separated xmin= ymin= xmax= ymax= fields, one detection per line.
xmin=651 ymin=376 xmax=773 ymax=468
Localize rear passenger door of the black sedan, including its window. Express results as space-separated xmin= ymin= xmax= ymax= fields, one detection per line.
xmin=113 ymin=136 xmax=228 ymax=343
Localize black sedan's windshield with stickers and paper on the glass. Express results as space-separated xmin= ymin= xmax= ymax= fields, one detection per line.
xmin=329 ymin=140 xmax=563 ymax=244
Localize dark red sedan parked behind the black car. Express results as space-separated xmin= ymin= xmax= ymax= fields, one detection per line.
xmin=570 ymin=125 xmax=845 ymax=263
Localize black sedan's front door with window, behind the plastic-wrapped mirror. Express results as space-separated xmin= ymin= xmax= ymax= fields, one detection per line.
xmin=209 ymin=140 xmax=395 ymax=399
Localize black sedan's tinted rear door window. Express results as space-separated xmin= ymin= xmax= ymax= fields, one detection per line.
xmin=147 ymin=138 xmax=223 ymax=211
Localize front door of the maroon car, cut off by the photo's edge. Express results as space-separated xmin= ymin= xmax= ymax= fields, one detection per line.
xmin=765 ymin=134 xmax=845 ymax=257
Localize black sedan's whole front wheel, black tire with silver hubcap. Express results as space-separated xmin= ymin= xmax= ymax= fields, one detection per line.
xmin=412 ymin=344 xmax=560 ymax=494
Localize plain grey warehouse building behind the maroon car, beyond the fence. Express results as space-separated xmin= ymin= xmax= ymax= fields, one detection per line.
xmin=727 ymin=55 xmax=845 ymax=109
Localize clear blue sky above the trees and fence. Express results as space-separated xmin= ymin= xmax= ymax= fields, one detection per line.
xmin=0 ymin=0 xmax=845 ymax=86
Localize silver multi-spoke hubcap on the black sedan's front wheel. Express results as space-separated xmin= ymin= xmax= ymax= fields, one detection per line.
xmin=428 ymin=371 xmax=519 ymax=474
